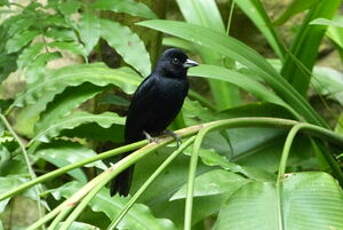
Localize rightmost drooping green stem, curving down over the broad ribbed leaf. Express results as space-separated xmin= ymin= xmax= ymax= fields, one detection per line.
xmin=275 ymin=123 xmax=306 ymax=229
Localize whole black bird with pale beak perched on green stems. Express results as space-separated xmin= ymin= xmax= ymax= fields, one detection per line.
xmin=111 ymin=48 xmax=198 ymax=196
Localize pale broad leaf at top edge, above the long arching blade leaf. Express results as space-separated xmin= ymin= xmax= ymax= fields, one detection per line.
xmin=177 ymin=0 xmax=225 ymax=33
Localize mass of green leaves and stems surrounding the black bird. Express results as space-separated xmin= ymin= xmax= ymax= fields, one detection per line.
xmin=0 ymin=0 xmax=343 ymax=230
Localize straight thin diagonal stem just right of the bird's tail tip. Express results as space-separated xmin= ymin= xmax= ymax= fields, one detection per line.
xmin=107 ymin=136 xmax=195 ymax=230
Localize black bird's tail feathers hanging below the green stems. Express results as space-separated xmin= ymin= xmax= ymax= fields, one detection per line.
xmin=110 ymin=153 xmax=135 ymax=196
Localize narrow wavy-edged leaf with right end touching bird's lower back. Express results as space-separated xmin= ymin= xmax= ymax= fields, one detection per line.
xmin=31 ymin=111 xmax=125 ymax=142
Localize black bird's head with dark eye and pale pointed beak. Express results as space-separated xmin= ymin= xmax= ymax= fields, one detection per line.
xmin=155 ymin=48 xmax=198 ymax=78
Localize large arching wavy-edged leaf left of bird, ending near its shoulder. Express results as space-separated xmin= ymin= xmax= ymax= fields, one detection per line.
xmin=11 ymin=63 xmax=141 ymax=136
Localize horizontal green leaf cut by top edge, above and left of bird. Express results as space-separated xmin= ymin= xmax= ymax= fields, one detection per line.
xmin=91 ymin=0 xmax=157 ymax=19
